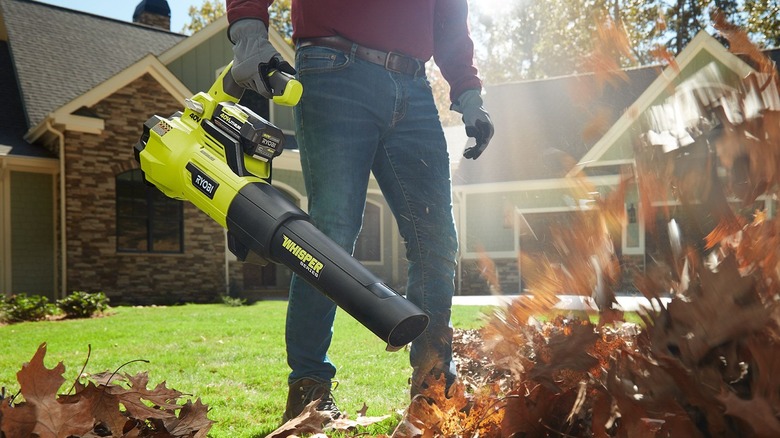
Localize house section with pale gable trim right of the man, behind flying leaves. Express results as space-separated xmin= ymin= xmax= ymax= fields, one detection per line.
xmin=454 ymin=32 xmax=780 ymax=293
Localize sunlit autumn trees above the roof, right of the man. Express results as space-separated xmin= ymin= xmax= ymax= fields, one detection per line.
xmin=471 ymin=0 xmax=780 ymax=83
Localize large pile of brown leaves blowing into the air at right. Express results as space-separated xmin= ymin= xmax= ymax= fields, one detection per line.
xmin=386 ymin=14 xmax=780 ymax=438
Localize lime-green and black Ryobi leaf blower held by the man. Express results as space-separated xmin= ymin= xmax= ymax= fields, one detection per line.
xmin=134 ymin=64 xmax=428 ymax=351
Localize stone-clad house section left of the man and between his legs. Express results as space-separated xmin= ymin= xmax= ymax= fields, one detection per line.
xmin=0 ymin=0 xmax=414 ymax=304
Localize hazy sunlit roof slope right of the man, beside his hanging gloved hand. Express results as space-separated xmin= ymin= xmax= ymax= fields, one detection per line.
xmin=453 ymin=66 xmax=661 ymax=185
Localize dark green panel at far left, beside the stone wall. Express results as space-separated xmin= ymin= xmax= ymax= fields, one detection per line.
xmin=10 ymin=172 xmax=55 ymax=298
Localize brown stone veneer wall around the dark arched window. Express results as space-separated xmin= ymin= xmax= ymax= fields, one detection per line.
xmin=65 ymin=74 xmax=226 ymax=305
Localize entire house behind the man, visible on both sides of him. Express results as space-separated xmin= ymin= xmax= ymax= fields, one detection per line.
xmin=0 ymin=0 xmax=772 ymax=304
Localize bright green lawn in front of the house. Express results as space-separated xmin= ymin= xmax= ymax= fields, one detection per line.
xmin=0 ymin=301 xmax=488 ymax=437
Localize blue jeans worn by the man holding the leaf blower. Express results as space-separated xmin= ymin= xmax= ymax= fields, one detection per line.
xmin=286 ymin=47 xmax=458 ymax=382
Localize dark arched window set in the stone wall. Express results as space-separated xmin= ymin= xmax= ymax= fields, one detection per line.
xmin=116 ymin=169 xmax=184 ymax=253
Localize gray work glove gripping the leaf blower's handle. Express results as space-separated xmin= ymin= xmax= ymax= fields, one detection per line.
xmin=228 ymin=18 xmax=295 ymax=99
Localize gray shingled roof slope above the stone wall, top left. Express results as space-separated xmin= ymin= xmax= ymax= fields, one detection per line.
xmin=0 ymin=0 xmax=186 ymax=130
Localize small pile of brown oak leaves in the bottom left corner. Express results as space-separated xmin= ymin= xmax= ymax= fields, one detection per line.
xmin=0 ymin=344 xmax=212 ymax=438
